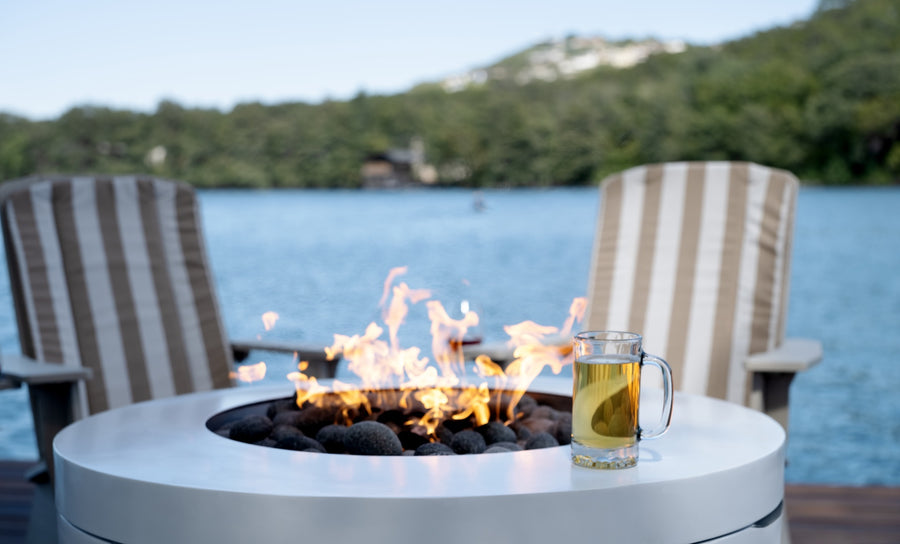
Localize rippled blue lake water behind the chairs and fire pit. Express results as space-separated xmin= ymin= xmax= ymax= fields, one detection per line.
xmin=0 ymin=188 xmax=900 ymax=485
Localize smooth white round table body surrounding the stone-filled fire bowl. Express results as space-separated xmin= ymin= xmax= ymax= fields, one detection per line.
xmin=54 ymin=378 xmax=785 ymax=544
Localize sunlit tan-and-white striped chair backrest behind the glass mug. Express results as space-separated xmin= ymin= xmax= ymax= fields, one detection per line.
xmin=585 ymin=162 xmax=798 ymax=405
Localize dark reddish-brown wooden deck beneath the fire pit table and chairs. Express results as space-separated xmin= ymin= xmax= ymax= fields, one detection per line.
xmin=0 ymin=461 xmax=900 ymax=544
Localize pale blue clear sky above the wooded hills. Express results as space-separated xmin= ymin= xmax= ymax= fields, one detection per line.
xmin=0 ymin=0 xmax=818 ymax=120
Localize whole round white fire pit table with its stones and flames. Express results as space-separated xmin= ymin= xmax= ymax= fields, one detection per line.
xmin=54 ymin=269 xmax=784 ymax=544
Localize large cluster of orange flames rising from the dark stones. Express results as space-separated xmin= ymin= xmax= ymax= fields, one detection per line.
xmin=284 ymin=267 xmax=586 ymax=437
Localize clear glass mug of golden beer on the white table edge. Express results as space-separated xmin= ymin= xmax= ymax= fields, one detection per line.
xmin=571 ymin=331 xmax=674 ymax=469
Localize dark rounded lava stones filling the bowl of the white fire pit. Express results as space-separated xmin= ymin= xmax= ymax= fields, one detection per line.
xmin=206 ymin=390 xmax=572 ymax=455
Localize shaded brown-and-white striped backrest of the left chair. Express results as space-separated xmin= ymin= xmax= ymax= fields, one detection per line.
xmin=0 ymin=176 xmax=232 ymax=413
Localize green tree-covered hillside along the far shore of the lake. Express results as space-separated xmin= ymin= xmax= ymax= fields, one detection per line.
xmin=0 ymin=0 xmax=900 ymax=188
